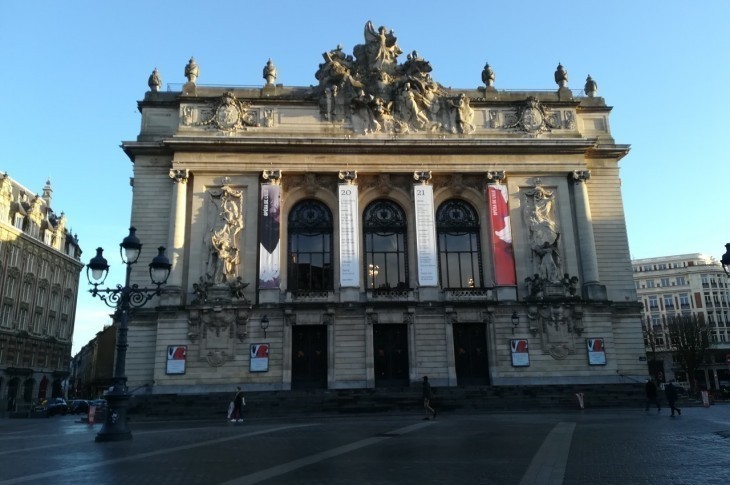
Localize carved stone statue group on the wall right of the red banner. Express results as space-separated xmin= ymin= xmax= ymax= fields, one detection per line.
xmin=522 ymin=184 xmax=563 ymax=284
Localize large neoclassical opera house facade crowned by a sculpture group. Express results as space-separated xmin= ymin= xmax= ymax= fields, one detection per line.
xmin=123 ymin=22 xmax=647 ymax=393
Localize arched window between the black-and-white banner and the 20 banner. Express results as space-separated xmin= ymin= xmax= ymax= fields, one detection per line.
xmin=287 ymin=200 xmax=334 ymax=292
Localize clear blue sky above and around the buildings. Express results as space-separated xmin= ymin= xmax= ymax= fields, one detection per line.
xmin=0 ymin=0 xmax=730 ymax=352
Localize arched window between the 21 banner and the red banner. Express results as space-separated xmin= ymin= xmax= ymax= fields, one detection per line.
xmin=436 ymin=199 xmax=484 ymax=288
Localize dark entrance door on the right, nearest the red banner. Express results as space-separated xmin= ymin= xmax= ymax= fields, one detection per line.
xmin=454 ymin=323 xmax=489 ymax=386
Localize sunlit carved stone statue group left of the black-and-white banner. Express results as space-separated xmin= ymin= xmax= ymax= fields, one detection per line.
xmin=206 ymin=185 xmax=244 ymax=285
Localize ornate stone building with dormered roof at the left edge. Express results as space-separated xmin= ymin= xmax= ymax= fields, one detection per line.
xmin=0 ymin=173 xmax=83 ymax=412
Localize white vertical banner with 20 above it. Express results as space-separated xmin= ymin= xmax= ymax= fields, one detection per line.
xmin=338 ymin=184 xmax=360 ymax=288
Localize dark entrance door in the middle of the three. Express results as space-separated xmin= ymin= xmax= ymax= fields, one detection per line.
xmin=373 ymin=324 xmax=409 ymax=387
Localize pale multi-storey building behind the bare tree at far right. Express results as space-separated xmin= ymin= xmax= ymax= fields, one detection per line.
xmin=632 ymin=253 xmax=730 ymax=389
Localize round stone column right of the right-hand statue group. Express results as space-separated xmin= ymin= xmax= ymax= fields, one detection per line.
xmin=570 ymin=170 xmax=606 ymax=300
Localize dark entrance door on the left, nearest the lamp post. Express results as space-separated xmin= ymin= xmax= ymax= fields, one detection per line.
xmin=291 ymin=325 xmax=327 ymax=389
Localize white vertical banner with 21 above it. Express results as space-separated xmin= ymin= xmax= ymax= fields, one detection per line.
xmin=413 ymin=184 xmax=438 ymax=286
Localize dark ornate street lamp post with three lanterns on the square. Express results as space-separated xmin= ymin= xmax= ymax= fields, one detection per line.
xmin=86 ymin=227 xmax=172 ymax=441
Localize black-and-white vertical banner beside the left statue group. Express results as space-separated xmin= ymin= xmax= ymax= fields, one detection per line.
xmin=259 ymin=184 xmax=281 ymax=289
